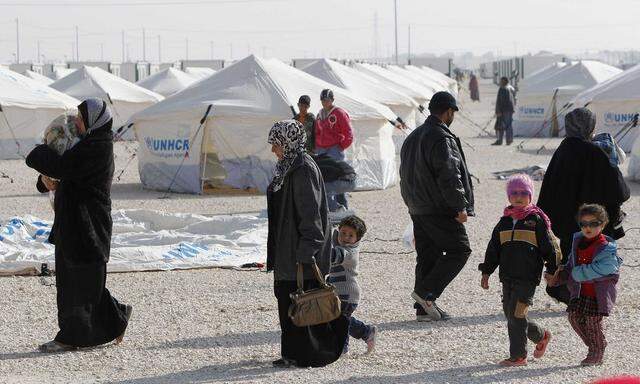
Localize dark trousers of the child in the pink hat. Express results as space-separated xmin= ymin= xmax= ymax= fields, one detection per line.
xmin=502 ymin=281 xmax=544 ymax=359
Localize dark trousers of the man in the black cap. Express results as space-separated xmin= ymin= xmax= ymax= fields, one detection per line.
xmin=411 ymin=215 xmax=471 ymax=301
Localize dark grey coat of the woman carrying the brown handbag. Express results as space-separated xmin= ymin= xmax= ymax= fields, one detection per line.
xmin=267 ymin=153 xmax=331 ymax=281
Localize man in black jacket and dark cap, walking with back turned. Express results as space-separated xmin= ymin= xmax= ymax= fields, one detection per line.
xmin=400 ymin=92 xmax=474 ymax=321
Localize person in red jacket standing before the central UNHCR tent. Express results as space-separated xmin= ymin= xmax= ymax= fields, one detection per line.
xmin=316 ymin=89 xmax=353 ymax=212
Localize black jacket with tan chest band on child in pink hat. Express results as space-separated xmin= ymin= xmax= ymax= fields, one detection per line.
xmin=478 ymin=214 xmax=562 ymax=285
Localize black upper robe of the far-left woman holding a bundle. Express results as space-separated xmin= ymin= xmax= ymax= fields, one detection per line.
xmin=26 ymin=124 xmax=114 ymax=264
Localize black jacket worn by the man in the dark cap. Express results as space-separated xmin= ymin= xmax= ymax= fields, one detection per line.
xmin=400 ymin=116 xmax=474 ymax=217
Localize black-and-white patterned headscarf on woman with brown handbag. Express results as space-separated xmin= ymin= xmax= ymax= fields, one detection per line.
xmin=267 ymin=120 xmax=307 ymax=192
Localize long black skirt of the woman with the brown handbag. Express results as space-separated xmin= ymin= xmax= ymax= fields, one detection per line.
xmin=274 ymin=280 xmax=349 ymax=367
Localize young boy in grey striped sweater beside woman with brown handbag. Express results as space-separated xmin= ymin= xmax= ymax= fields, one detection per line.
xmin=327 ymin=216 xmax=376 ymax=353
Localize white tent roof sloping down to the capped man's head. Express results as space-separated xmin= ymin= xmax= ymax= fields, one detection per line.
xmin=353 ymin=63 xmax=433 ymax=125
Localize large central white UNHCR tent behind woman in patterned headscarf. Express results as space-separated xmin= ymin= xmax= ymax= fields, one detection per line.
xmin=131 ymin=56 xmax=397 ymax=193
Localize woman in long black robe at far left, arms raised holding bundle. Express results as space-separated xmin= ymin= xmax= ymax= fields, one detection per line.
xmin=26 ymin=99 xmax=132 ymax=352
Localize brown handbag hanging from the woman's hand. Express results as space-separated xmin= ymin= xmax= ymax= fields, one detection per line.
xmin=289 ymin=261 xmax=341 ymax=327
